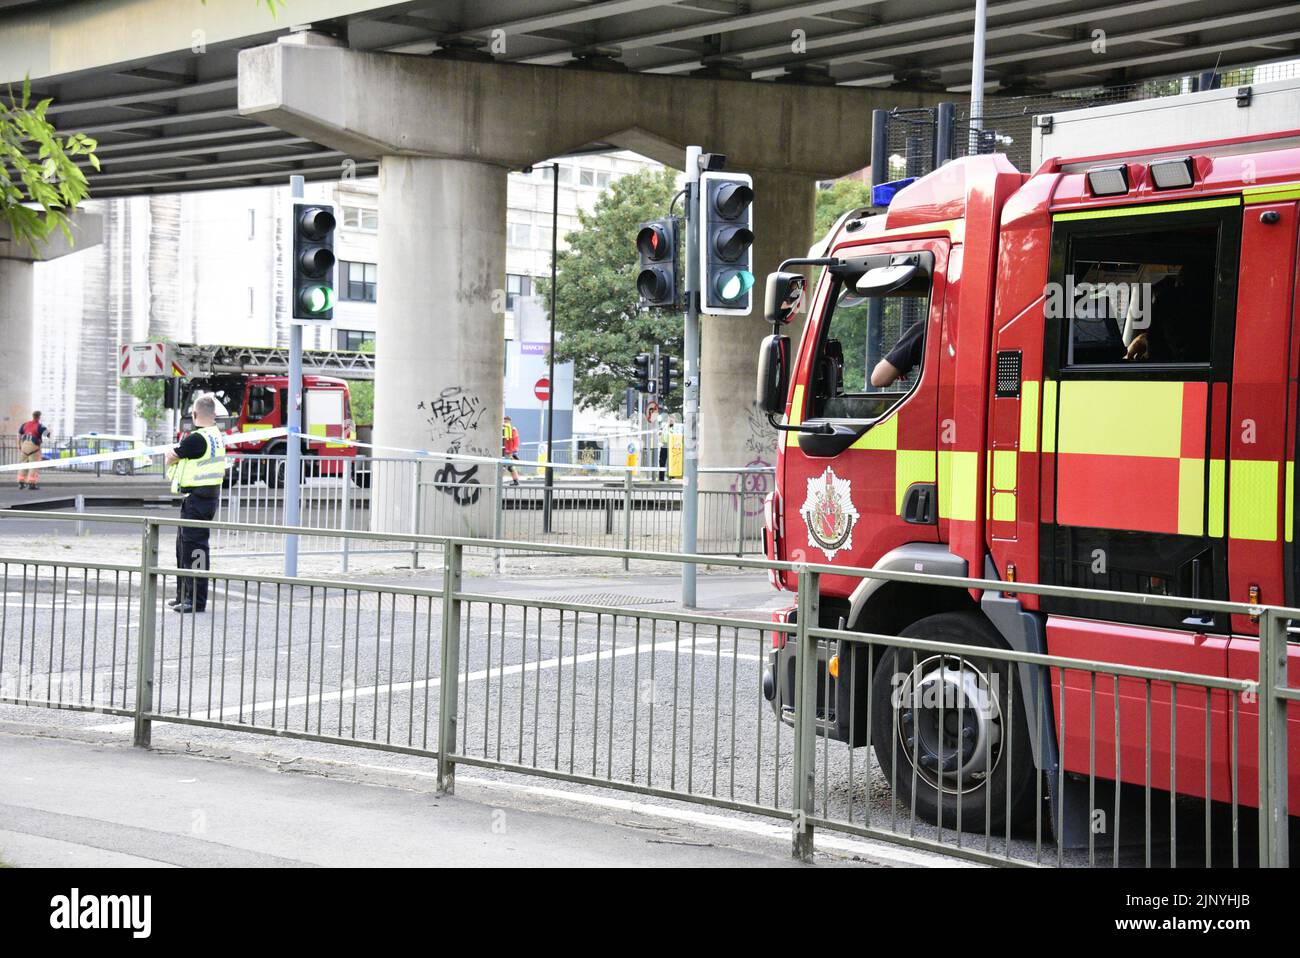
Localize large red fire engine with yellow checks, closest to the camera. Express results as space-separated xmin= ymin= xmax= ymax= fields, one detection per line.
xmin=758 ymin=81 xmax=1300 ymax=828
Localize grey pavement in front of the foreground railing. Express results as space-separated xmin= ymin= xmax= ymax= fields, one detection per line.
xmin=0 ymin=723 xmax=915 ymax=868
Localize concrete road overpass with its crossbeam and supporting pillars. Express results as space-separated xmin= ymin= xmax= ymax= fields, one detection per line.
xmin=0 ymin=0 xmax=1300 ymax=526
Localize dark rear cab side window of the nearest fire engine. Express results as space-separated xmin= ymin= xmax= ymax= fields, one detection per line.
xmin=1060 ymin=224 xmax=1218 ymax=365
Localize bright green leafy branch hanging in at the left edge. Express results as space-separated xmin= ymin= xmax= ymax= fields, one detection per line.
xmin=0 ymin=81 xmax=99 ymax=250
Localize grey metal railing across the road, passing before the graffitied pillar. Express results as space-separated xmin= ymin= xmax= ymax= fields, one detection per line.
xmin=208 ymin=455 xmax=774 ymax=571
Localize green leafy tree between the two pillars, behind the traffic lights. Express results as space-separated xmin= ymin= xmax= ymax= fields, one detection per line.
xmin=538 ymin=169 xmax=685 ymax=411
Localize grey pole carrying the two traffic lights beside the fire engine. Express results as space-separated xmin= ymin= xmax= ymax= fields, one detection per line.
xmin=681 ymin=147 xmax=703 ymax=608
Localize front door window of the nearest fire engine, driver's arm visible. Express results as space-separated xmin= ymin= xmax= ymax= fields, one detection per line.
xmin=810 ymin=269 xmax=930 ymax=420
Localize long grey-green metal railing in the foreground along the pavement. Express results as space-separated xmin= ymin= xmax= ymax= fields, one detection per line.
xmin=0 ymin=512 xmax=1300 ymax=866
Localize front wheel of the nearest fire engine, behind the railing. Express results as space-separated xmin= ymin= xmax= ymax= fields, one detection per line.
xmin=871 ymin=612 xmax=1035 ymax=832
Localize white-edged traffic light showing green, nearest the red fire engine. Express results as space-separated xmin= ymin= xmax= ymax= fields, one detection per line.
xmin=699 ymin=172 xmax=754 ymax=316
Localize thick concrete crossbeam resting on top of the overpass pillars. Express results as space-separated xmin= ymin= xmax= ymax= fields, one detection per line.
xmin=239 ymin=43 xmax=933 ymax=178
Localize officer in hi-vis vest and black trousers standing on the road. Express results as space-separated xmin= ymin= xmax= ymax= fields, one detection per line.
xmin=166 ymin=395 xmax=226 ymax=612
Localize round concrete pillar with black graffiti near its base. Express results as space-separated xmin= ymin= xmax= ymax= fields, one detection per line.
xmin=374 ymin=155 xmax=506 ymax=534
